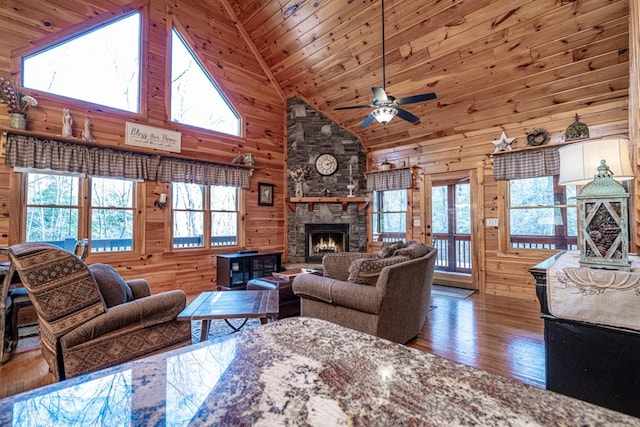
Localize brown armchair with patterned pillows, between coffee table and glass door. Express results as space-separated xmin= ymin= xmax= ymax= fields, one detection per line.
xmin=293 ymin=241 xmax=437 ymax=343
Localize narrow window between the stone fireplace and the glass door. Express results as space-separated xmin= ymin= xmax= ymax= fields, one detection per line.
xmin=372 ymin=190 xmax=407 ymax=242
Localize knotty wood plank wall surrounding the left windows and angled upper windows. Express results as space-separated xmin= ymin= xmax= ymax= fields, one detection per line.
xmin=0 ymin=0 xmax=286 ymax=294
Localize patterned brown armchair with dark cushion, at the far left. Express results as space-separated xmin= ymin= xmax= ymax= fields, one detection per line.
xmin=9 ymin=243 xmax=191 ymax=380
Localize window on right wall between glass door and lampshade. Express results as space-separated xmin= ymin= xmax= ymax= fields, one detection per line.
xmin=509 ymin=176 xmax=578 ymax=249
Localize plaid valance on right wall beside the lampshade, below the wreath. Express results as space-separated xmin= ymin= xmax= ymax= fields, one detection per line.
xmin=493 ymin=147 xmax=560 ymax=180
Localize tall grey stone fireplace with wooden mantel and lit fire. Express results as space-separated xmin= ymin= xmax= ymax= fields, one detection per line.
xmin=287 ymin=98 xmax=366 ymax=264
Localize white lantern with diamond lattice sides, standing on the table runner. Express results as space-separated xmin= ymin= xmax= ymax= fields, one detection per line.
xmin=577 ymin=160 xmax=630 ymax=271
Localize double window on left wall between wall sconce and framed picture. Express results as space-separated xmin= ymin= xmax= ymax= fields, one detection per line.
xmin=171 ymin=182 xmax=240 ymax=248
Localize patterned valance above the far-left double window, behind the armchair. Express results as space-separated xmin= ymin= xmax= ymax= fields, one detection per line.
xmin=5 ymin=134 xmax=158 ymax=180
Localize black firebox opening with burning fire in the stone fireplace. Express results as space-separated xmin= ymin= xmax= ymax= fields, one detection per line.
xmin=304 ymin=224 xmax=349 ymax=263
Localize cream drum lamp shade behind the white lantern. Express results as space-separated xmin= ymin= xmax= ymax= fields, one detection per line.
xmin=558 ymin=139 xmax=634 ymax=185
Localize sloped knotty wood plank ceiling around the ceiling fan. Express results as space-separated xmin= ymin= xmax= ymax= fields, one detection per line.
xmin=226 ymin=0 xmax=629 ymax=150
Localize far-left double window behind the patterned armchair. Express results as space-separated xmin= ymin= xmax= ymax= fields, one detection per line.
xmin=23 ymin=172 xmax=136 ymax=252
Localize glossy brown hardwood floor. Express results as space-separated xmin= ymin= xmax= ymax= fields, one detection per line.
xmin=0 ymin=294 xmax=545 ymax=398
